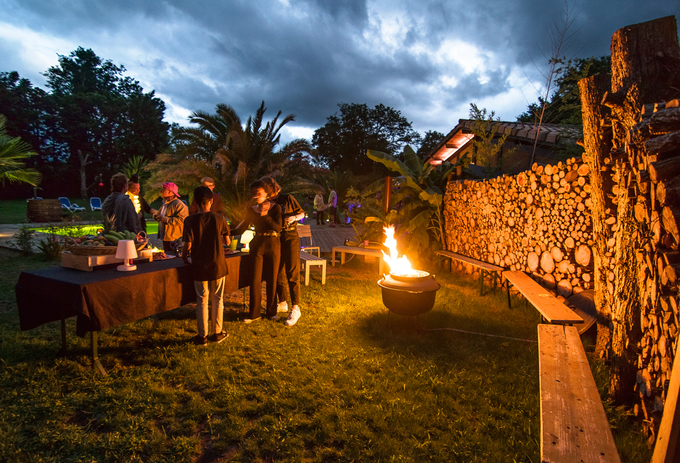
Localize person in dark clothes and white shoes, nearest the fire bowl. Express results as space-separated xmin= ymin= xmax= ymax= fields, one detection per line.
xmin=262 ymin=177 xmax=305 ymax=326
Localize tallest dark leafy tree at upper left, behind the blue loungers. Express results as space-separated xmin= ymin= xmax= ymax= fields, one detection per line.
xmin=44 ymin=47 xmax=168 ymax=196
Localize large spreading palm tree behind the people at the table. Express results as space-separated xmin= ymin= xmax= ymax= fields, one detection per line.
xmin=146 ymin=101 xmax=312 ymax=220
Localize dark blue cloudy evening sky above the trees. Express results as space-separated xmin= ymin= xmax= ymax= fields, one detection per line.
xmin=0 ymin=0 xmax=680 ymax=143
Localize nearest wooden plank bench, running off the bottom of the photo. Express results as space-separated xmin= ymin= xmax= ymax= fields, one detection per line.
xmin=538 ymin=324 xmax=621 ymax=463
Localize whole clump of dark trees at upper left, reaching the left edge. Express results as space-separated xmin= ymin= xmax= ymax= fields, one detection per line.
xmin=0 ymin=47 xmax=169 ymax=196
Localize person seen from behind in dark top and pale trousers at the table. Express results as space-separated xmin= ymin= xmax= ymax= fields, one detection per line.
xmin=182 ymin=186 xmax=230 ymax=346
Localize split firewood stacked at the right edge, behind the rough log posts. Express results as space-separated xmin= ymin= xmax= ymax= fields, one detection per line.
xmin=624 ymin=100 xmax=680 ymax=432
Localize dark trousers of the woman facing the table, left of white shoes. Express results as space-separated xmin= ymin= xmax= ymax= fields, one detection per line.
xmin=249 ymin=236 xmax=281 ymax=318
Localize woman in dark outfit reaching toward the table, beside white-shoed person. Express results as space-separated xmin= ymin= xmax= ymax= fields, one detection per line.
xmin=230 ymin=180 xmax=281 ymax=323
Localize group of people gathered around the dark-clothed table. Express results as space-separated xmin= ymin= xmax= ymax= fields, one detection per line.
xmin=102 ymin=174 xmax=314 ymax=345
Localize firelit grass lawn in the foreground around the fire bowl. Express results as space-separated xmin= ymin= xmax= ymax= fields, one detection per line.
xmin=0 ymin=250 xmax=651 ymax=462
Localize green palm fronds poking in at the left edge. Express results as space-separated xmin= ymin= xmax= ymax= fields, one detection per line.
xmin=0 ymin=114 xmax=42 ymax=186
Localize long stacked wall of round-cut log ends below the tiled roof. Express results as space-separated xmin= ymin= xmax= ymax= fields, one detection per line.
xmin=444 ymin=159 xmax=593 ymax=297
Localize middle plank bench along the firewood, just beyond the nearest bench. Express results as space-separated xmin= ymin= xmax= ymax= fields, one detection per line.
xmin=503 ymin=270 xmax=583 ymax=325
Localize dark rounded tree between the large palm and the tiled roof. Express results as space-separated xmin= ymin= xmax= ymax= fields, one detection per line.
xmin=312 ymin=103 xmax=420 ymax=175
